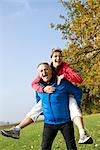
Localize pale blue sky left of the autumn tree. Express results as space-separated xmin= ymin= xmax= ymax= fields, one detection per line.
xmin=0 ymin=0 xmax=66 ymax=123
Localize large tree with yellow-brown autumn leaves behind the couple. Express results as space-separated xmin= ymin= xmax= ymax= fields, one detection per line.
xmin=51 ymin=0 xmax=100 ymax=112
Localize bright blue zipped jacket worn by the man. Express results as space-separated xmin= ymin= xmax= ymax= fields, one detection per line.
xmin=37 ymin=78 xmax=82 ymax=124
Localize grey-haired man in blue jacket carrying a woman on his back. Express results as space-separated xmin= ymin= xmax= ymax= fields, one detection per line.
xmin=33 ymin=63 xmax=82 ymax=150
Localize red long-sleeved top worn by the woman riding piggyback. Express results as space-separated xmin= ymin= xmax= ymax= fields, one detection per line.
xmin=32 ymin=62 xmax=83 ymax=92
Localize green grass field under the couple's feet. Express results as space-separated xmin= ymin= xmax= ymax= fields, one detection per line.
xmin=0 ymin=114 xmax=100 ymax=150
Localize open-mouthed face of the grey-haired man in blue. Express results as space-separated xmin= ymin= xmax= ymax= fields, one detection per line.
xmin=37 ymin=64 xmax=52 ymax=82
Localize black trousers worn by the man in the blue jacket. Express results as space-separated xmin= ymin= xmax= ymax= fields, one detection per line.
xmin=42 ymin=121 xmax=77 ymax=150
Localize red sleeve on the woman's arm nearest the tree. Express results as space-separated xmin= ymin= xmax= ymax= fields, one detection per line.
xmin=63 ymin=64 xmax=83 ymax=83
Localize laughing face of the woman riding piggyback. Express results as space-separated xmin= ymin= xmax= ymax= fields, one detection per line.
xmin=52 ymin=52 xmax=62 ymax=68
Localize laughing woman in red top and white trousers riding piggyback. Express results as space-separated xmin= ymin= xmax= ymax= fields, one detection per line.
xmin=1 ymin=49 xmax=93 ymax=144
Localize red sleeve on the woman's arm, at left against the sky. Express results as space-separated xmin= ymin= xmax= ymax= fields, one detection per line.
xmin=32 ymin=76 xmax=43 ymax=92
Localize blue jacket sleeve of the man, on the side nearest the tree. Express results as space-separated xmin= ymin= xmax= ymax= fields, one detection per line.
xmin=66 ymin=81 xmax=82 ymax=107
